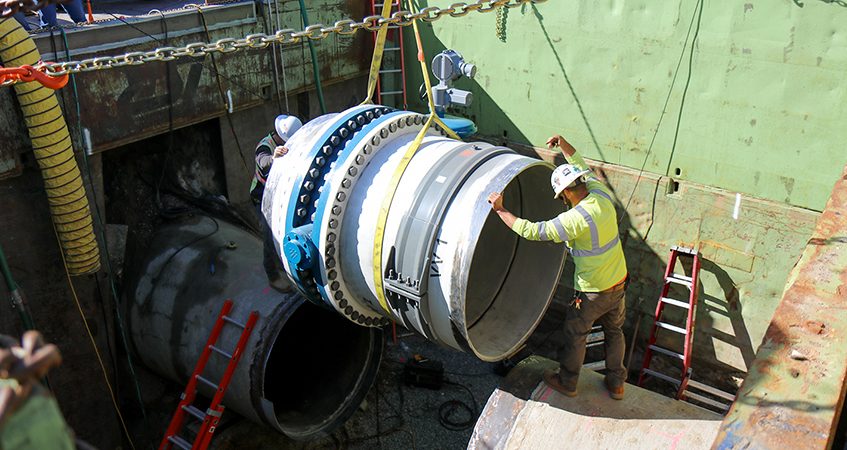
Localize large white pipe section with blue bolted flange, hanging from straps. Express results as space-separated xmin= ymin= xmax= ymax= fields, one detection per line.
xmin=262 ymin=105 xmax=565 ymax=361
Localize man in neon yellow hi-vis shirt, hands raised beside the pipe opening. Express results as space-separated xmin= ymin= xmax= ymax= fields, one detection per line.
xmin=488 ymin=135 xmax=627 ymax=400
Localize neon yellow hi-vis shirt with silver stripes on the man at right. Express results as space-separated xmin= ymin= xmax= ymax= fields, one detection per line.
xmin=512 ymin=153 xmax=627 ymax=292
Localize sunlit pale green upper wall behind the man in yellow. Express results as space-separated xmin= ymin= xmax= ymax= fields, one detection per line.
xmin=406 ymin=0 xmax=847 ymax=211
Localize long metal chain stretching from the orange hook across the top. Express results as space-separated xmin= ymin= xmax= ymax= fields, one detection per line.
xmin=0 ymin=0 xmax=547 ymax=86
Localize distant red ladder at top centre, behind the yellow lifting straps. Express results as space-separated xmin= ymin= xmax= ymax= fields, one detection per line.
xmin=371 ymin=0 xmax=408 ymax=110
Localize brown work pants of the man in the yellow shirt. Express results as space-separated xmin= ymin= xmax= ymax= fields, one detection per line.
xmin=559 ymin=289 xmax=626 ymax=390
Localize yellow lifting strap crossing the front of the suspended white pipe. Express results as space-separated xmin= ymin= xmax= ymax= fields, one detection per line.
xmin=373 ymin=0 xmax=461 ymax=314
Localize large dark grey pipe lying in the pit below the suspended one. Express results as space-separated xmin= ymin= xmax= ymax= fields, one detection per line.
xmin=128 ymin=217 xmax=384 ymax=439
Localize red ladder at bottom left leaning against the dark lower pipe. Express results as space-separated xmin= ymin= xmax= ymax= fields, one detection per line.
xmin=159 ymin=300 xmax=259 ymax=450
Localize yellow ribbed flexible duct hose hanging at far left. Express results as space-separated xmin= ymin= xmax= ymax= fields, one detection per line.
xmin=0 ymin=18 xmax=100 ymax=275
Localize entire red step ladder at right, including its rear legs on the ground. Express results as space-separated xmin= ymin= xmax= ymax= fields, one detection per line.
xmin=638 ymin=246 xmax=735 ymax=412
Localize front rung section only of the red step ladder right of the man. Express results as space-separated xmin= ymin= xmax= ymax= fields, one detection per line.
xmin=638 ymin=246 xmax=700 ymax=399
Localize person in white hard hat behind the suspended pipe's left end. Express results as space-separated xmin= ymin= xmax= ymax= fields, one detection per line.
xmin=250 ymin=114 xmax=303 ymax=292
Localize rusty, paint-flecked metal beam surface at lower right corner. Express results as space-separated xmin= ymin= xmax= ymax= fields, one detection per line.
xmin=713 ymin=168 xmax=847 ymax=449
